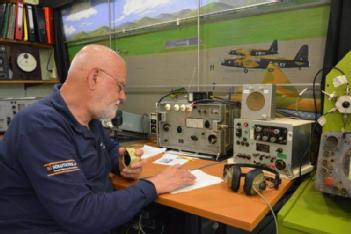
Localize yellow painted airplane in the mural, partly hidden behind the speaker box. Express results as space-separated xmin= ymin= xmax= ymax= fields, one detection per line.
xmin=232 ymin=61 xmax=321 ymax=112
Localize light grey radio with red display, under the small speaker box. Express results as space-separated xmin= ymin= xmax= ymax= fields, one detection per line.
xmin=234 ymin=118 xmax=313 ymax=178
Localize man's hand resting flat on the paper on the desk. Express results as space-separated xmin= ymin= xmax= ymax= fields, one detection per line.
xmin=147 ymin=165 xmax=196 ymax=194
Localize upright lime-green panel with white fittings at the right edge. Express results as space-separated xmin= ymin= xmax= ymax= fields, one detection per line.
xmin=323 ymin=51 xmax=351 ymax=132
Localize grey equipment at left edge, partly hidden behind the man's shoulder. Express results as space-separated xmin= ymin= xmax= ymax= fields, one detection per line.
xmin=0 ymin=97 xmax=39 ymax=132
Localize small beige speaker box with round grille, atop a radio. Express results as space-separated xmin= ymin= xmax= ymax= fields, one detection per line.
xmin=241 ymin=84 xmax=275 ymax=119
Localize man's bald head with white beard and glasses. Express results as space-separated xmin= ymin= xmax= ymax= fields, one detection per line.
xmin=60 ymin=45 xmax=127 ymax=125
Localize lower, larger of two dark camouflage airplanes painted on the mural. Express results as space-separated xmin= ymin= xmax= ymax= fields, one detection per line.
xmin=221 ymin=45 xmax=309 ymax=73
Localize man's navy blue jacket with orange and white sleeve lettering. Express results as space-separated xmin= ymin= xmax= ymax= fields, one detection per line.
xmin=0 ymin=87 xmax=157 ymax=234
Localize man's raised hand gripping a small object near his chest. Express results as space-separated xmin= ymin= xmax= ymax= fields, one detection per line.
xmin=119 ymin=148 xmax=145 ymax=179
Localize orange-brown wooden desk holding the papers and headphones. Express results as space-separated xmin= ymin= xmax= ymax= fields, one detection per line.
xmin=112 ymin=156 xmax=292 ymax=231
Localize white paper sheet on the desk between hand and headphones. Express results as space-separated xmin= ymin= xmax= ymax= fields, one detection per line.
xmin=171 ymin=170 xmax=223 ymax=194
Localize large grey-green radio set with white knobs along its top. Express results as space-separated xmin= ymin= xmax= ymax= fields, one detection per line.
xmin=157 ymin=100 xmax=240 ymax=160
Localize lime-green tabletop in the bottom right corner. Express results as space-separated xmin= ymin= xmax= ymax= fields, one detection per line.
xmin=278 ymin=178 xmax=351 ymax=234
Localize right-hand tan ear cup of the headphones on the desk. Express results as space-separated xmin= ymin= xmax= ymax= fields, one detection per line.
xmin=244 ymin=169 xmax=266 ymax=195
